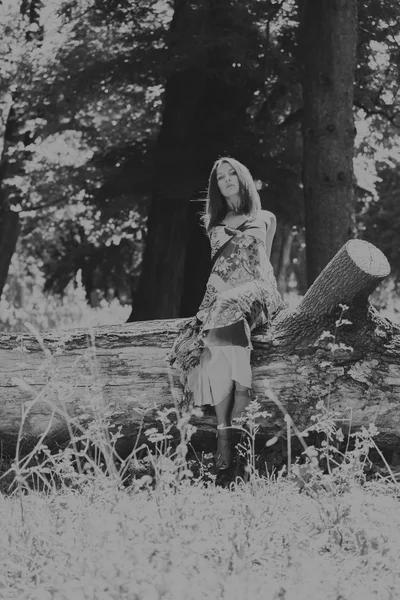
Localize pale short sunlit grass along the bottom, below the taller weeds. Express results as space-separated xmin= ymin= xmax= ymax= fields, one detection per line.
xmin=0 ymin=476 xmax=400 ymax=600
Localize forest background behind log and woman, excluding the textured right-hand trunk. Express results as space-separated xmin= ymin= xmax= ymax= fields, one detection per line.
xmin=0 ymin=0 xmax=400 ymax=331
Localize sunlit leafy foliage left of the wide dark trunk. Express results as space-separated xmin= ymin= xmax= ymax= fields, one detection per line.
xmin=0 ymin=0 xmax=169 ymax=302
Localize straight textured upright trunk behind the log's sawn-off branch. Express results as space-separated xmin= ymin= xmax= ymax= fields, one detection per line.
xmin=299 ymin=0 xmax=357 ymax=285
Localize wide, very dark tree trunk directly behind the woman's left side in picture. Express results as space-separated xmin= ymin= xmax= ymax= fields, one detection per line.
xmin=129 ymin=0 xmax=262 ymax=321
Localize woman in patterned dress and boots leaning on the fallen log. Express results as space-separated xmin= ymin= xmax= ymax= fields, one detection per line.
xmin=169 ymin=158 xmax=282 ymax=470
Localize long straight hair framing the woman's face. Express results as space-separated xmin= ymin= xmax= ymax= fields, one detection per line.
xmin=202 ymin=156 xmax=261 ymax=231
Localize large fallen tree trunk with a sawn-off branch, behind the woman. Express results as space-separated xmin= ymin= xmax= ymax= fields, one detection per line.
xmin=0 ymin=240 xmax=400 ymax=455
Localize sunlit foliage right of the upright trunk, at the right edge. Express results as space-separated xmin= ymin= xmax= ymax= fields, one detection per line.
xmin=355 ymin=0 xmax=400 ymax=279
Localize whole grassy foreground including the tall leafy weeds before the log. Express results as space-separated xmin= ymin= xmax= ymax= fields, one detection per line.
xmin=0 ymin=296 xmax=400 ymax=600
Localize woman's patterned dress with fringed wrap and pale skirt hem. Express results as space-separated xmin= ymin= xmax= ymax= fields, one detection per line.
xmin=169 ymin=214 xmax=282 ymax=405
